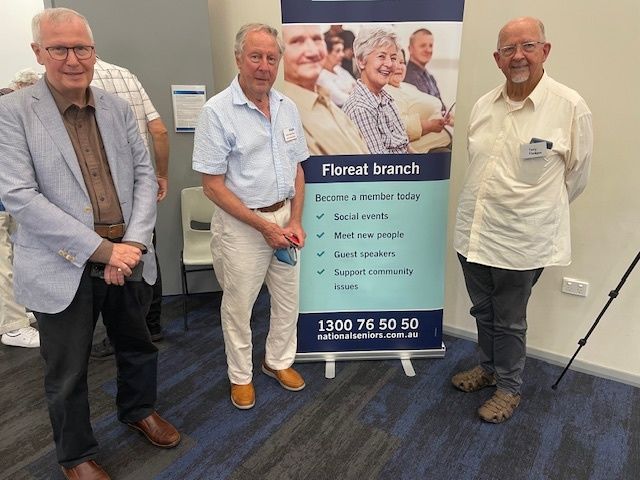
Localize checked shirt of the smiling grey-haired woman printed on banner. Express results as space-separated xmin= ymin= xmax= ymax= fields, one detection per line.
xmin=342 ymin=80 xmax=409 ymax=153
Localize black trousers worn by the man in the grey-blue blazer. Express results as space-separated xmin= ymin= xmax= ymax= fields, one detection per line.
xmin=34 ymin=265 xmax=158 ymax=468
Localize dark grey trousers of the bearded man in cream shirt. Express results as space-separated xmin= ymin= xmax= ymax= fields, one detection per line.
xmin=458 ymin=254 xmax=543 ymax=393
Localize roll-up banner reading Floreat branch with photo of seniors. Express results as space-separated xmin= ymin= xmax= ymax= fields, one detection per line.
xmin=281 ymin=0 xmax=464 ymax=361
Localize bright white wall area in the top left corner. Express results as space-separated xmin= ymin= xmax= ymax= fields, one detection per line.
xmin=0 ymin=0 xmax=44 ymax=87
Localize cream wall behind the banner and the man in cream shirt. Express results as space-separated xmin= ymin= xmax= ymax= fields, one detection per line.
xmin=209 ymin=0 xmax=640 ymax=385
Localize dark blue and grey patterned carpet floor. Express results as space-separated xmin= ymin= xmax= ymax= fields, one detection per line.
xmin=0 ymin=294 xmax=640 ymax=480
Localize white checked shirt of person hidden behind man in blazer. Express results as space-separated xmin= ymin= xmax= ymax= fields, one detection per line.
xmin=91 ymin=59 xmax=160 ymax=150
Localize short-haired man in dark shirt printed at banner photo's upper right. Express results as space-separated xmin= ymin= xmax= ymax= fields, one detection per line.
xmin=404 ymin=28 xmax=452 ymax=117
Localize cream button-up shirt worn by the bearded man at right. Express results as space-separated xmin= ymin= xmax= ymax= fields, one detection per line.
xmin=454 ymin=73 xmax=593 ymax=270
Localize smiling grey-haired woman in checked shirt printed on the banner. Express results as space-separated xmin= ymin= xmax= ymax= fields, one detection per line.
xmin=343 ymin=26 xmax=409 ymax=153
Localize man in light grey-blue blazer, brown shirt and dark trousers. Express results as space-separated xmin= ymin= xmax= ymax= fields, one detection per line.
xmin=0 ymin=8 xmax=180 ymax=478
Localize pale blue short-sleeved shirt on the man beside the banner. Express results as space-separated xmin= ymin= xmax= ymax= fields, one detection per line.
xmin=193 ymin=77 xmax=309 ymax=208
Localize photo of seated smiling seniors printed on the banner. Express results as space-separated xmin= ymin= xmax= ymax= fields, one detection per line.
xmin=282 ymin=22 xmax=462 ymax=155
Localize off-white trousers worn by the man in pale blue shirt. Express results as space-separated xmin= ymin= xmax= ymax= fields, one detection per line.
xmin=211 ymin=201 xmax=300 ymax=385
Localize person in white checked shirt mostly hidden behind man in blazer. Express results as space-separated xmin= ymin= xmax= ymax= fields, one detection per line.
xmin=91 ymin=58 xmax=169 ymax=358
